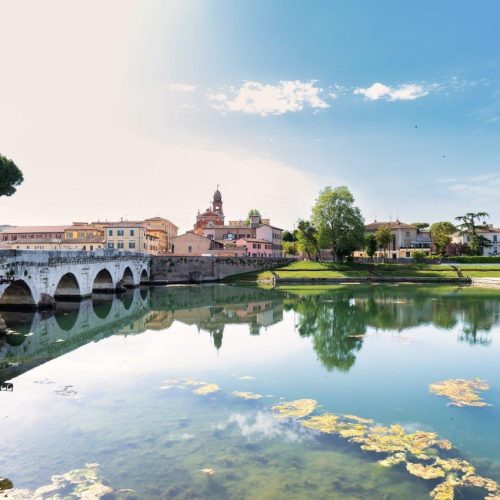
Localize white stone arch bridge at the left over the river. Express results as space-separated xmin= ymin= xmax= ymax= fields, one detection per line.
xmin=0 ymin=250 xmax=150 ymax=309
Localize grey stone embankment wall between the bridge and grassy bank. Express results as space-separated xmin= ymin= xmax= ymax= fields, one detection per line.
xmin=150 ymin=256 xmax=293 ymax=284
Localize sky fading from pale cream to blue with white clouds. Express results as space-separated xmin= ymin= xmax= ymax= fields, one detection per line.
xmin=0 ymin=0 xmax=500 ymax=231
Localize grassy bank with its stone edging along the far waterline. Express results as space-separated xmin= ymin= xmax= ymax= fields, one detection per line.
xmin=225 ymin=261 xmax=500 ymax=286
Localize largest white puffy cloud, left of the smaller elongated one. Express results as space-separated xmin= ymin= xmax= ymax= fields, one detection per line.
xmin=208 ymin=80 xmax=330 ymax=116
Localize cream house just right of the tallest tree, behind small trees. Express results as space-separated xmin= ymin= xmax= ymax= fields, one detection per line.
xmin=354 ymin=220 xmax=432 ymax=259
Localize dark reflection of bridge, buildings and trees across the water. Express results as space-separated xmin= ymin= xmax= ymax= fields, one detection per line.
xmin=0 ymin=285 xmax=500 ymax=383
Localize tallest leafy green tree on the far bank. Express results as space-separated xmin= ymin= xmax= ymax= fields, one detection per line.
xmin=311 ymin=186 xmax=364 ymax=259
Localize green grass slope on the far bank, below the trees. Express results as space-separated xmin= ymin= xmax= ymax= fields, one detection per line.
xmin=225 ymin=261 xmax=500 ymax=282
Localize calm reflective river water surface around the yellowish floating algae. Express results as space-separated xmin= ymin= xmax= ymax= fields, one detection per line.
xmin=0 ymin=285 xmax=500 ymax=499
